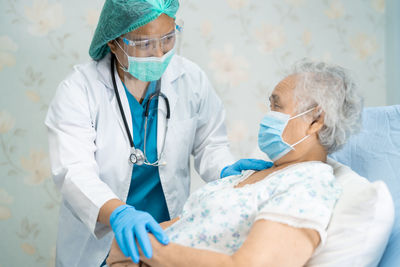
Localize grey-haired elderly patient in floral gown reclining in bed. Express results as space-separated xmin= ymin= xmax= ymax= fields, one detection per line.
xmin=107 ymin=60 xmax=362 ymax=267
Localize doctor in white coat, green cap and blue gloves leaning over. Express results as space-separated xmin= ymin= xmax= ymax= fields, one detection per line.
xmin=45 ymin=0 xmax=266 ymax=267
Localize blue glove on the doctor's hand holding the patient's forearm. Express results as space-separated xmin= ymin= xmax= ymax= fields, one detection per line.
xmin=110 ymin=205 xmax=169 ymax=263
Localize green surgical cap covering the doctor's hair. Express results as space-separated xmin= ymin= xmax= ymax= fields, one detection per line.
xmin=89 ymin=0 xmax=179 ymax=60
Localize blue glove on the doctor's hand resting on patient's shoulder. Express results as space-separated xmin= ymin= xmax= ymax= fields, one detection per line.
xmin=221 ymin=159 xmax=274 ymax=178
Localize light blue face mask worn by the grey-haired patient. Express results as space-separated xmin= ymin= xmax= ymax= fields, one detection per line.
xmin=258 ymin=108 xmax=314 ymax=161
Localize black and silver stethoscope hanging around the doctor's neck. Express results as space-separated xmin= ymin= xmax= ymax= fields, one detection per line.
xmin=111 ymin=55 xmax=170 ymax=166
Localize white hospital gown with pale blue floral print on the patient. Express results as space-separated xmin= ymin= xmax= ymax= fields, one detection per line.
xmin=166 ymin=161 xmax=341 ymax=255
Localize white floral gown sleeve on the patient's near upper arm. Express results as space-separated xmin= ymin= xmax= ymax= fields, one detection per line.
xmin=255 ymin=173 xmax=341 ymax=252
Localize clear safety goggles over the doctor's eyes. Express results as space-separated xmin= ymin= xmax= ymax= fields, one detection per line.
xmin=120 ymin=24 xmax=183 ymax=53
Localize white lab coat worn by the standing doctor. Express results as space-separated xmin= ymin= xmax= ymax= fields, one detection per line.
xmin=45 ymin=55 xmax=233 ymax=267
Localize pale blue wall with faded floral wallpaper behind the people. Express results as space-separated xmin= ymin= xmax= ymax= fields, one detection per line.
xmin=0 ymin=0 xmax=386 ymax=267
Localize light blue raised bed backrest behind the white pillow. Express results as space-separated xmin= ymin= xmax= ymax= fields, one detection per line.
xmin=330 ymin=105 xmax=400 ymax=267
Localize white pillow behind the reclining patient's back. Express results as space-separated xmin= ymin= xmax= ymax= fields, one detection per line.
xmin=306 ymin=159 xmax=394 ymax=267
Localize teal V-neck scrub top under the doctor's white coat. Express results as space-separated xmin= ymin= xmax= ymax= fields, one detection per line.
xmin=124 ymin=81 xmax=170 ymax=223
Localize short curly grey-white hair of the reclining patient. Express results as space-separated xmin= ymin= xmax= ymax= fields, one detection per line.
xmin=290 ymin=59 xmax=363 ymax=153
